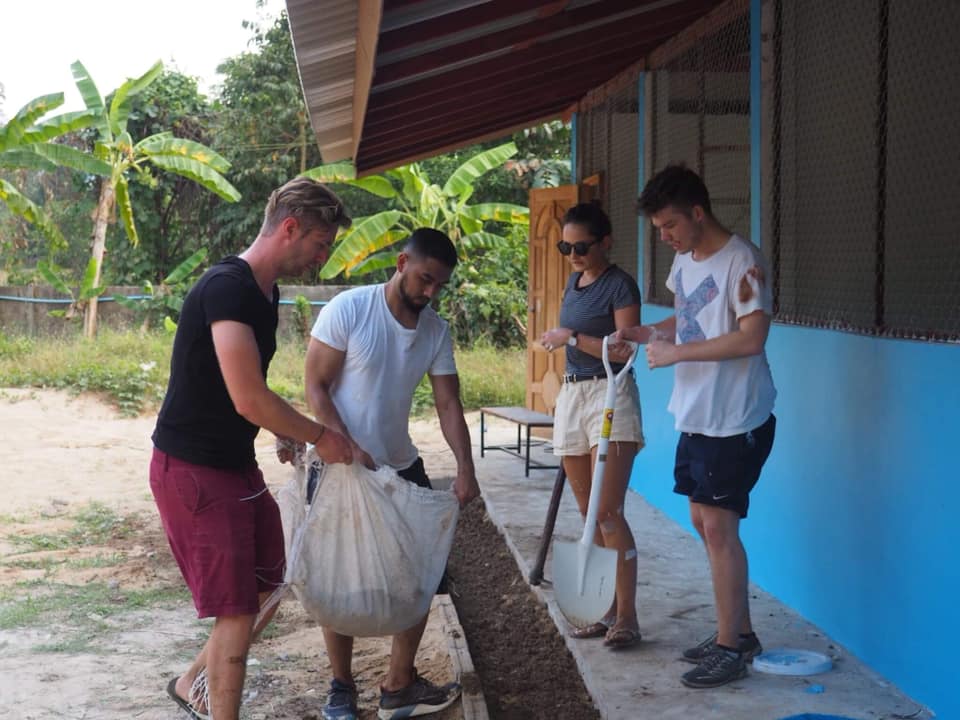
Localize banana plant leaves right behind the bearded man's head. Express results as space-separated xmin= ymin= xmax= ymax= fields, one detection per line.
xmin=304 ymin=142 xmax=530 ymax=279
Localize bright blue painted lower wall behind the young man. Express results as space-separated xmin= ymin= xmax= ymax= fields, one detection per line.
xmin=631 ymin=320 xmax=960 ymax=718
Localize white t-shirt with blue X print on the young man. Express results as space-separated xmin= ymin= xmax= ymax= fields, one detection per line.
xmin=667 ymin=235 xmax=777 ymax=437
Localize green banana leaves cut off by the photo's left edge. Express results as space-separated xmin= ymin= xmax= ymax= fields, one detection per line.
xmin=0 ymin=93 xmax=110 ymax=249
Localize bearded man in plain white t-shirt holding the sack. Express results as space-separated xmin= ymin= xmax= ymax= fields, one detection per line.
xmin=305 ymin=228 xmax=480 ymax=720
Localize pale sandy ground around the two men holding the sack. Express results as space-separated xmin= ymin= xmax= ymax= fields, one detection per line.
xmin=0 ymin=389 xmax=464 ymax=720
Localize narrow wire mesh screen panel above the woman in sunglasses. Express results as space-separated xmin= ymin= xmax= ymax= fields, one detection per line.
xmin=577 ymin=84 xmax=640 ymax=284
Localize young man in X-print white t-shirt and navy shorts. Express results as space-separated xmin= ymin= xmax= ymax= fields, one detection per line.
xmin=620 ymin=165 xmax=776 ymax=688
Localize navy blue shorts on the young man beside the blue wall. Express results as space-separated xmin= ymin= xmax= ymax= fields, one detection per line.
xmin=673 ymin=415 xmax=777 ymax=518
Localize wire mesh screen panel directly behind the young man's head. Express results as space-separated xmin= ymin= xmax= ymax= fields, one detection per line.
xmin=644 ymin=12 xmax=750 ymax=305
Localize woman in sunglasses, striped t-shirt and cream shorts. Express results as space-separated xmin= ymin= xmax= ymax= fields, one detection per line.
xmin=540 ymin=203 xmax=643 ymax=648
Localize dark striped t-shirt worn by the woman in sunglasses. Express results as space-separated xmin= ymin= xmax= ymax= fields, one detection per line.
xmin=560 ymin=265 xmax=640 ymax=375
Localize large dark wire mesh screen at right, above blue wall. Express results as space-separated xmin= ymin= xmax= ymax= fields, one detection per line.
xmin=764 ymin=0 xmax=960 ymax=340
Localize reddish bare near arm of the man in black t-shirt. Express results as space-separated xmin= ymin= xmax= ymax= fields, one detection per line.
xmin=210 ymin=320 xmax=352 ymax=462
